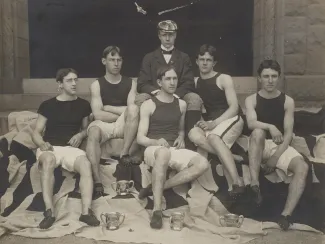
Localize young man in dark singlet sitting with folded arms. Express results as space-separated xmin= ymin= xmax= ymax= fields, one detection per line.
xmin=86 ymin=46 xmax=139 ymax=197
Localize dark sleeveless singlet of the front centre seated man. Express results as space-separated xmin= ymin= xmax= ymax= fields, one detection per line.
xmin=147 ymin=97 xmax=182 ymax=146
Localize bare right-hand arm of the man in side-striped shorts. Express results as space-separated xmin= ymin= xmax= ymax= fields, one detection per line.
xmin=214 ymin=75 xmax=239 ymax=126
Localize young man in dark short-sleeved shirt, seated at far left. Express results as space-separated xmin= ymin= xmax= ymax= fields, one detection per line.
xmin=32 ymin=69 xmax=99 ymax=229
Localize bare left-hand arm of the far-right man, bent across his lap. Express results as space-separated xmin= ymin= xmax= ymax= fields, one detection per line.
xmin=245 ymin=94 xmax=274 ymax=131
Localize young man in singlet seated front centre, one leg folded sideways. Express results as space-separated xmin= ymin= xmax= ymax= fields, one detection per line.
xmin=137 ymin=66 xmax=209 ymax=229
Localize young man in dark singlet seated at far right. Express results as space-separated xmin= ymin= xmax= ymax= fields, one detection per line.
xmin=245 ymin=60 xmax=308 ymax=230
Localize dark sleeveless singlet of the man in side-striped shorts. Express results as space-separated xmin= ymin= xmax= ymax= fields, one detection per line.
xmin=196 ymin=73 xmax=229 ymax=120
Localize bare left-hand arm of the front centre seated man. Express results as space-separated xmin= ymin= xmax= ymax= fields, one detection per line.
xmin=137 ymin=100 xmax=158 ymax=147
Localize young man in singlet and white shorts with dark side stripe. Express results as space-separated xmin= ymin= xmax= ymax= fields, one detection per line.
xmin=189 ymin=44 xmax=245 ymax=198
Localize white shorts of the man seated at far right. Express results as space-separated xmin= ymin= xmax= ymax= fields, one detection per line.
xmin=262 ymin=139 xmax=302 ymax=176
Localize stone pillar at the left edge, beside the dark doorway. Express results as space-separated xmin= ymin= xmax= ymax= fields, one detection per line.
xmin=0 ymin=0 xmax=30 ymax=94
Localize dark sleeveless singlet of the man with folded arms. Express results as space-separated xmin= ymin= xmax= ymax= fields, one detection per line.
xmin=98 ymin=76 xmax=132 ymax=106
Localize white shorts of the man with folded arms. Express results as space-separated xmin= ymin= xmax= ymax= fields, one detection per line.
xmin=87 ymin=113 xmax=125 ymax=143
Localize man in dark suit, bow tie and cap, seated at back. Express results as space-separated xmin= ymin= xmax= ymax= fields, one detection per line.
xmin=136 ymin=20 xmax=202 ymax=150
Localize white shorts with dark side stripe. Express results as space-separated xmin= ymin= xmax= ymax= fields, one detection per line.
xmin=205 ymin=115 xmax=244 ymax=148
